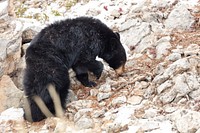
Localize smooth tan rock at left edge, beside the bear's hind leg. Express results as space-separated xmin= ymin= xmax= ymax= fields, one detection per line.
xmin=0 ymin=75 xmax=23 ymax=112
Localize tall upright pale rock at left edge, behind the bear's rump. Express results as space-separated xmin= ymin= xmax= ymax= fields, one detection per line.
xmin=0 ymin=20 xmax=22 ymax=77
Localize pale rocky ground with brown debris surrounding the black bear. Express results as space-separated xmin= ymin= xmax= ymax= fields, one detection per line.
xmin=0 ymin=0 xmax=200 ymax=133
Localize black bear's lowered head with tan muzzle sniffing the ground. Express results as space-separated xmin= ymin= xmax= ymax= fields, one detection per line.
xmin=101 ymin=32 xmax=127 ymax=75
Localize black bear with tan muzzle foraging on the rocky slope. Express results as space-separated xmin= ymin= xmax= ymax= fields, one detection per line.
xmin=23 ymin=17 xmax=126 ymax=121
